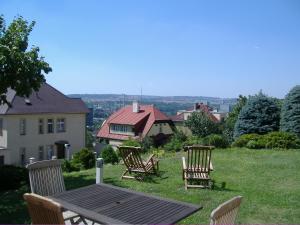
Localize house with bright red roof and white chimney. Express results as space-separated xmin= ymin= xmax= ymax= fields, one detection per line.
xmin=97 ymin=102 xmax=173 ymax=146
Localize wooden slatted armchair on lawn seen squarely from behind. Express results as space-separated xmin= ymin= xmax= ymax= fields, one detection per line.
xmin=182 ymin=146 xmax=214 ymax=190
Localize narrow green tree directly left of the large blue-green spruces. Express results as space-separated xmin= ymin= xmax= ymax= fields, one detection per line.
xmin=223 ymin=95 xmax=247 ymax=143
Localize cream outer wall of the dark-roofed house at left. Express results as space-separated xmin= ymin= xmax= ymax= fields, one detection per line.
xmin=0 ymin=113 xmax=86 ymax=165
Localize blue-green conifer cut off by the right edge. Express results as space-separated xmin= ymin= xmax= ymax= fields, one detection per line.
xmin=280 ymin=85 xmax=300 ymax=137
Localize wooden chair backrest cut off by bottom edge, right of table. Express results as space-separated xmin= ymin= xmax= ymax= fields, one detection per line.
xmin=210 ymin=196 xmax=242 ymax=225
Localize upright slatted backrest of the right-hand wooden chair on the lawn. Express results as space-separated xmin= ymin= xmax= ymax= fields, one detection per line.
xmin=184 ymin=145 xmax=214 ymax=174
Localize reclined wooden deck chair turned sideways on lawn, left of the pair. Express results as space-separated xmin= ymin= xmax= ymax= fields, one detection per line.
xmin=118 ymin=146 xmax=158 ymax=179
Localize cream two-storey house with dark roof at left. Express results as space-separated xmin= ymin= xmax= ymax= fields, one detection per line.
xmin=0 ymin=83 xmax=88 ymax=165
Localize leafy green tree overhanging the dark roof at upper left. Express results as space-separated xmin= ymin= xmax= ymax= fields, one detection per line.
xmin=0 ymin=16 xmax=52 ymax=105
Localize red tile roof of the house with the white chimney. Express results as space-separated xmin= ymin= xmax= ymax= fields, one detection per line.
xmin=97 ymin=105 xmax=170 ymax=140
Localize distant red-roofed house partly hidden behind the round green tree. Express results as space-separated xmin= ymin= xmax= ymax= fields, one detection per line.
xmin=170 ymin=102 xmax=220 ymax=135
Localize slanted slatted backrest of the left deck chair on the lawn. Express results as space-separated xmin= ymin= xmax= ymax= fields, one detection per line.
xmin=118 ymin=146 xmax=145 ymax=170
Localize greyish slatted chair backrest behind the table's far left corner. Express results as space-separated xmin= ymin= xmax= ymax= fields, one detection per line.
xmin=27 ymin=160 xmax=65 ymax=196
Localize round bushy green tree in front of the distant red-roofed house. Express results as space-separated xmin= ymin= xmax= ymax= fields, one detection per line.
xmin=185 ymin=111 xmax=218 ymax=137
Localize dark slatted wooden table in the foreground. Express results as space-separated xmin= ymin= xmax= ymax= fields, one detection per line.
xmin=49 ymin=184 xmax=202 ymax=224
